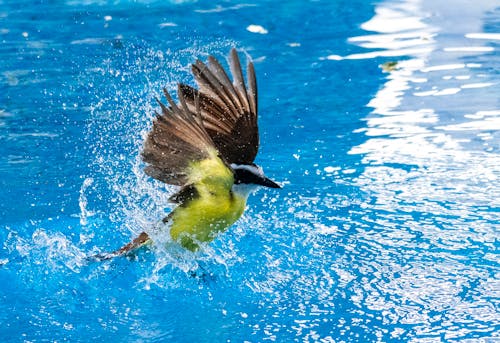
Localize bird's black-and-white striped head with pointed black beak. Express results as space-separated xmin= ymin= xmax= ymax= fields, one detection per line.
xmin=231 ymin=164 xmax=281 ymax=195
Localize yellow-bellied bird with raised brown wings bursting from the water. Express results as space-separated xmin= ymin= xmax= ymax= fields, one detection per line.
xmin=101 ymin=48 xmax=281 ymax=259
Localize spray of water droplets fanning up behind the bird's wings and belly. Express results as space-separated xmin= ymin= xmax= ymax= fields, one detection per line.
xmin=80 ymin=41 xmax=254 ymax=287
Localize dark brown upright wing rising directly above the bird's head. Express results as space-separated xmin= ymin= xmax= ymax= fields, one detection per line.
xmin=180 ymin=49 xmax=259 ymax=164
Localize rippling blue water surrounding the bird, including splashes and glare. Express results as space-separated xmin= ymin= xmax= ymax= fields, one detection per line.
xmin=0 ymin=0 xmax=500 ymax=342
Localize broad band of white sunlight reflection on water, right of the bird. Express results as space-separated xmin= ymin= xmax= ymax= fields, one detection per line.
xmin=328 ymin=1 xmax=500 ymax=340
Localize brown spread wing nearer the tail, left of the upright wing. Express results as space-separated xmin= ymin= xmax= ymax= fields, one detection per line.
xmin=142 ymin=85 xmax=228 ymax=186
